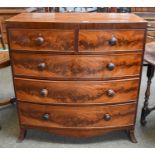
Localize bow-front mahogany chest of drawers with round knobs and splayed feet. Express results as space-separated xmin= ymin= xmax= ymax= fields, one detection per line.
xmin=6 ymin=13 xmax=147 ymax=142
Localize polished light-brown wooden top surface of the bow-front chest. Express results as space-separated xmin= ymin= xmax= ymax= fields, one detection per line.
xmin=7 ymin=13 xmax=146 ymax=23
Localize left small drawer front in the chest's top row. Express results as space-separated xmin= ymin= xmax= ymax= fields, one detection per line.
xmin=8 ymin=29 xmax=74 ymax=51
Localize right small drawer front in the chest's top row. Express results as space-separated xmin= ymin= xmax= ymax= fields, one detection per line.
xmin=78 ymin=30 xmax=145 ymax=52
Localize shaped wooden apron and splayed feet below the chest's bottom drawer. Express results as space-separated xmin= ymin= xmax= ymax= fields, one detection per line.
xmin=18 ymin=124 xmax=135 ymax=138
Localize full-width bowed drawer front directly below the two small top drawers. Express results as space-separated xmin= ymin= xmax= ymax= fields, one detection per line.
xmin=12 ymin=53 xmax=141 ymax=79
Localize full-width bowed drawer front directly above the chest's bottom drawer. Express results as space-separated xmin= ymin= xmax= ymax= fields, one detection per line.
xmin=15 ymin=78 xmax=139 ymax=104
